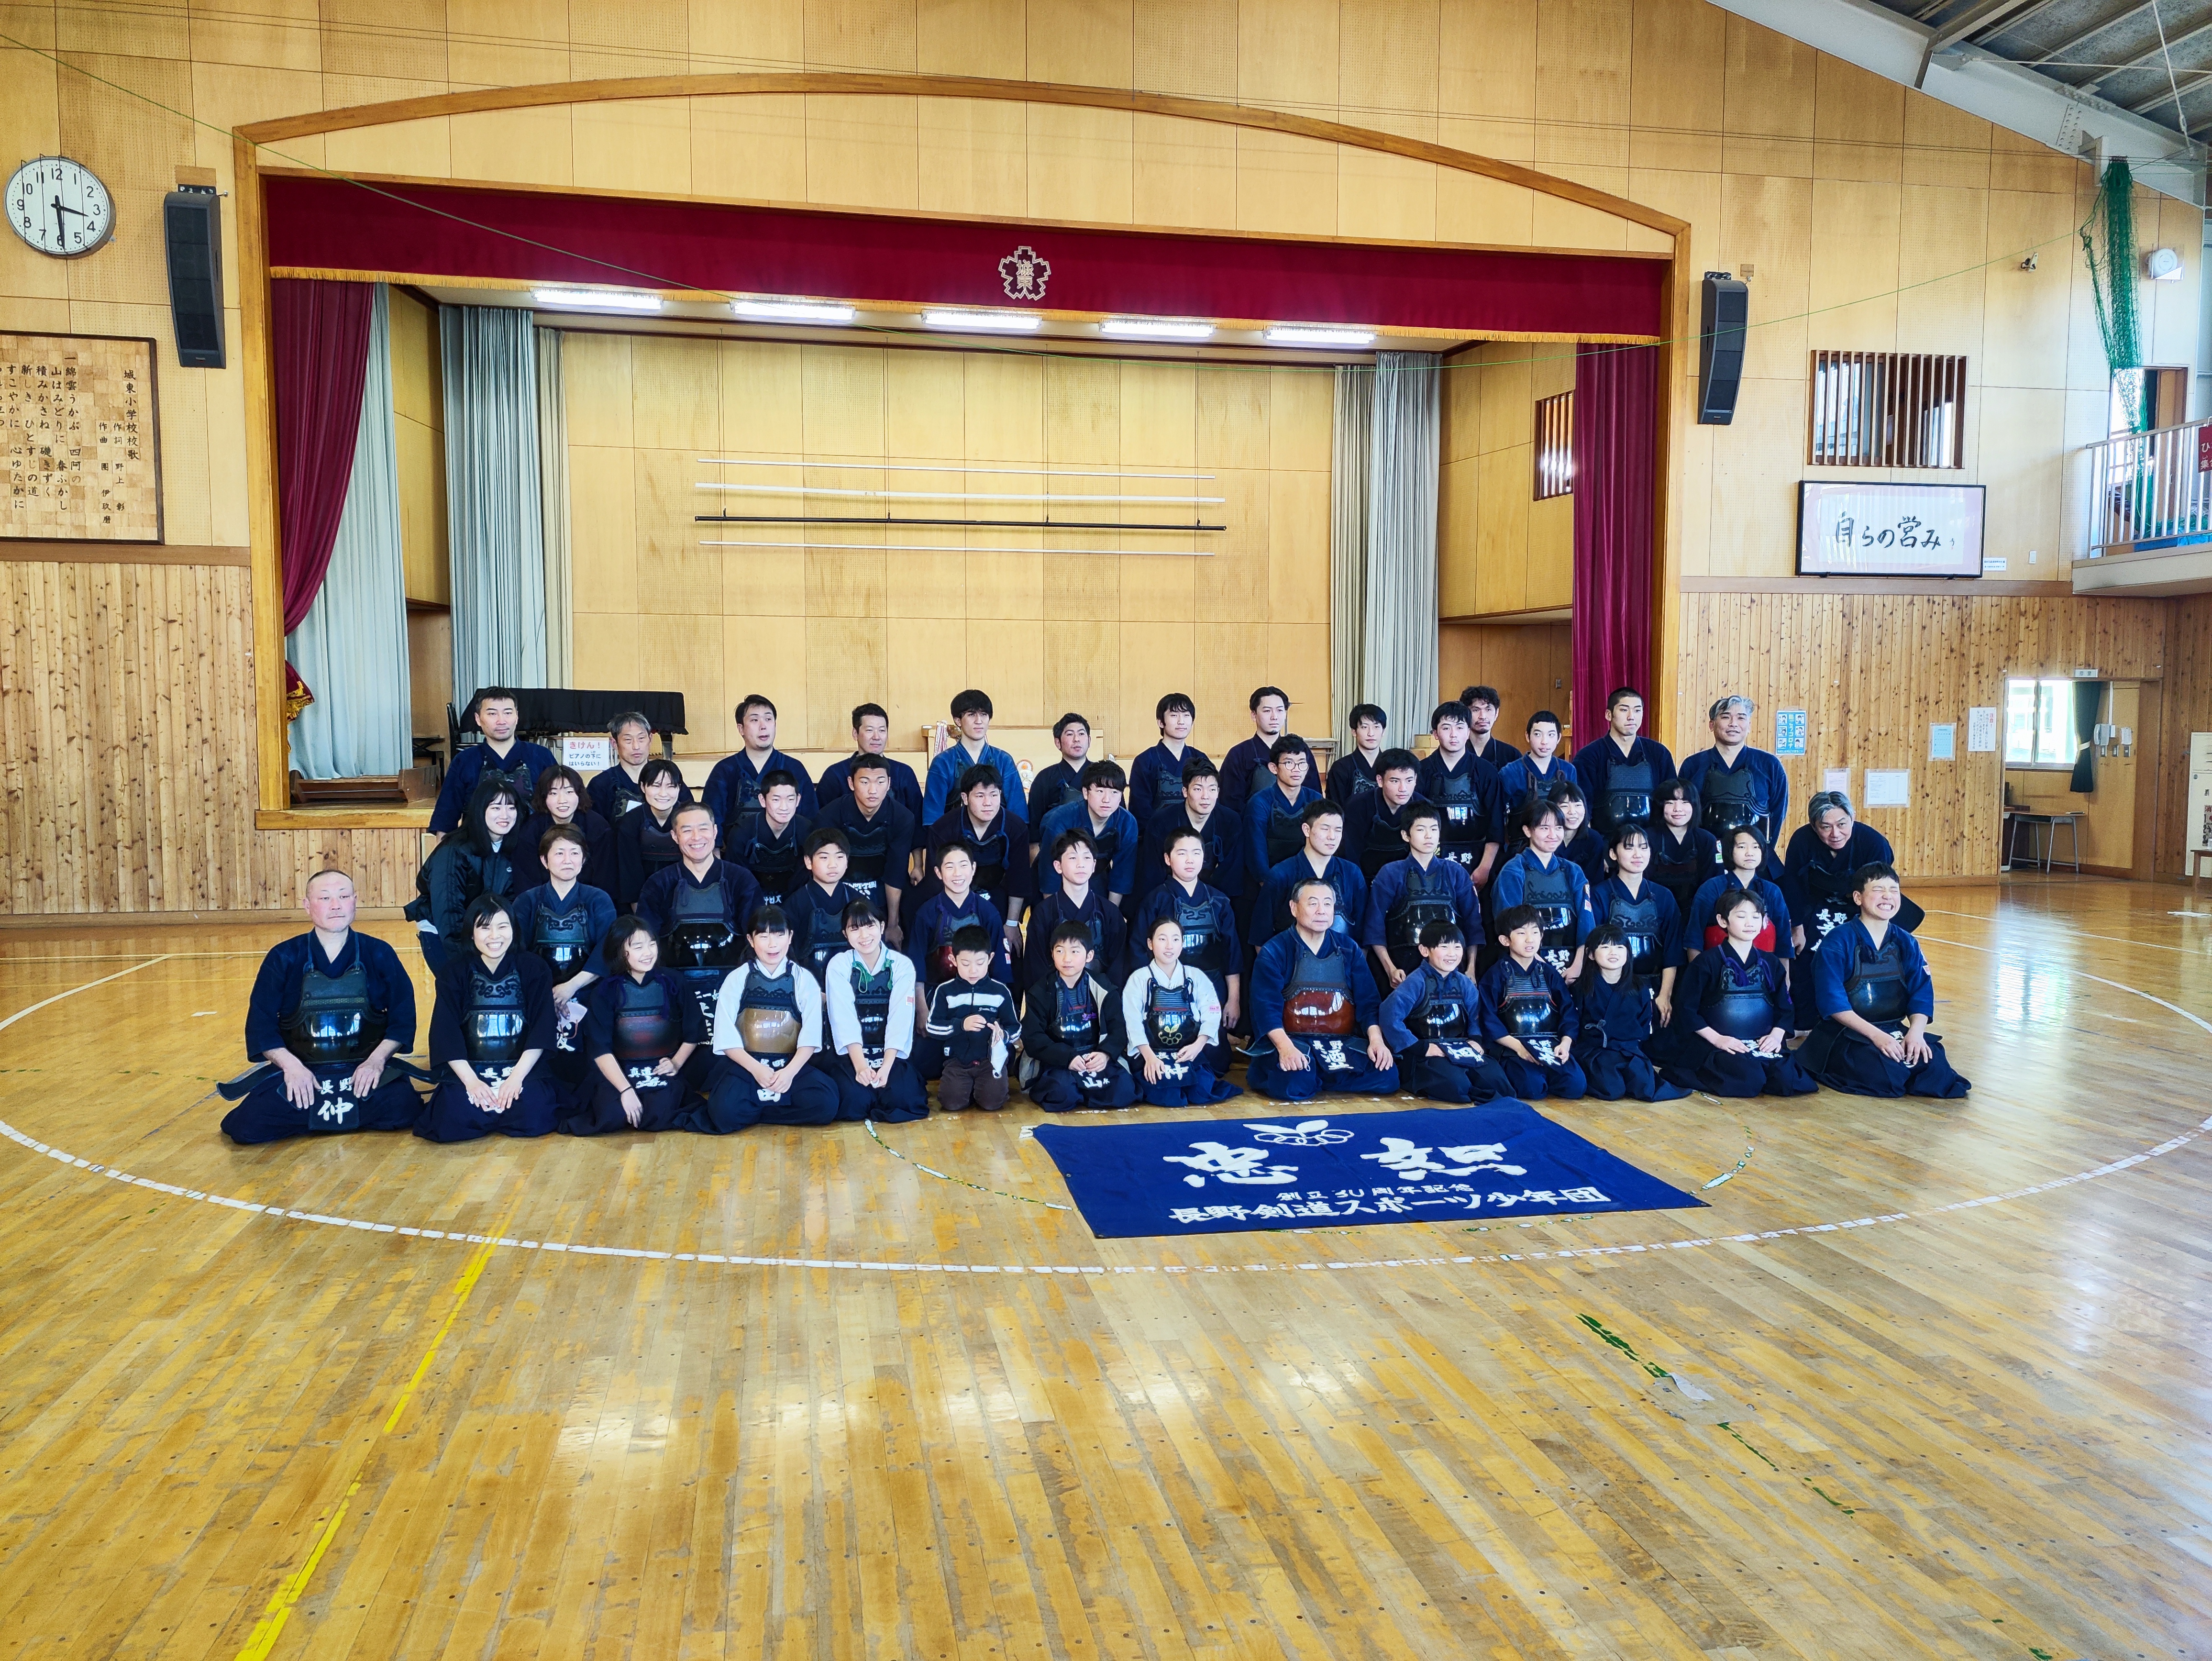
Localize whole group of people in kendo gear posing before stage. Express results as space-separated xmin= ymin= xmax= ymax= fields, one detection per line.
xmin=223 ymin=686 xmax=1969 ymax=1143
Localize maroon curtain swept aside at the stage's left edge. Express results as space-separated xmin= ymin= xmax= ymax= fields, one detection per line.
xmin=270 ymin=277 xmax=376 ymax=635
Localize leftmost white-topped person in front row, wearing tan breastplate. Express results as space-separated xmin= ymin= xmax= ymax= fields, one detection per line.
xmin=677 ymin=905 xmax=838 ymax=1137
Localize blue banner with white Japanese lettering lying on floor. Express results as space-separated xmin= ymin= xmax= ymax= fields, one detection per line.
xmin=1035 ymin=1101 xmax=1705 ymax=1241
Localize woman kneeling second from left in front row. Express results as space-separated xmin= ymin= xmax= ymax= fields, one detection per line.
xmin=416 ymin=894 xmax=560 ymax=1141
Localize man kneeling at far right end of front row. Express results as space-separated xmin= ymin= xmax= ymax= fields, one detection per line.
xmin=1798 ymin=863 xmax=1973 ymax=1101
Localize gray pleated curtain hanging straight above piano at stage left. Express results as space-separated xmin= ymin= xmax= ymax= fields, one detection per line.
xmin=438 ymin=305 xmax=546 ymax=708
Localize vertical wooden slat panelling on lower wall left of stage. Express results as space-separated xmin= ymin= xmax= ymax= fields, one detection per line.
xmin=0 ymin=562 xmax=418 ymax=916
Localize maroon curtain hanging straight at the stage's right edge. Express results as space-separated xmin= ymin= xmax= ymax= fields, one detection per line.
xmin=1573 ymin=345 xmax=1659 ymax=743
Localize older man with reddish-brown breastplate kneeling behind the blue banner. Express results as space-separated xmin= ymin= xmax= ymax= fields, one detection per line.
xmin=1245 ymin=876 xmax=1398 ymax=1101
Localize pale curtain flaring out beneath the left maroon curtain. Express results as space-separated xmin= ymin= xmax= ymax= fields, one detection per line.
xmin=285 ymin=283 xmax=414 ymax=778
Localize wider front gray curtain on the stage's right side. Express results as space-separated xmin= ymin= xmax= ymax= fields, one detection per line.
xmin=1360 ymin=352 xmax=1442 ymax=743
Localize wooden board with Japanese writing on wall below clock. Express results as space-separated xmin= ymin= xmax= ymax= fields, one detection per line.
xmin=0 ymin=334 xmax=162 ymax=542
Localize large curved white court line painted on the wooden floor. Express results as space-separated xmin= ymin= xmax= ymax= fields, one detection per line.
xmin=0 ymin=942 xmax=2212 ymax=1274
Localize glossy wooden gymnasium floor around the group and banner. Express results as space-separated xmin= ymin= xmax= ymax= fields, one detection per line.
xmin=0 ymin=880 xmax=2212 ymax=1661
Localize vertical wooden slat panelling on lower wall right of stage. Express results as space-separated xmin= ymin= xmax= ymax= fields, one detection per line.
xmin=1663 ymin=595 xmax=2159 ymax=878
